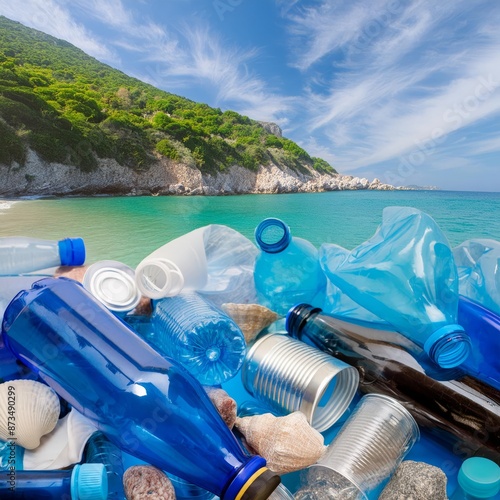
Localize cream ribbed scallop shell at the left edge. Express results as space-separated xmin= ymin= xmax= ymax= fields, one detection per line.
xmin=0 ymin=380 xmax=61 ymax=450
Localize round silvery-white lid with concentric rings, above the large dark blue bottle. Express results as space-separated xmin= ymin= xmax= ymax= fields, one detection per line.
xmin=83 ymin=260 xmax=141 ymax=312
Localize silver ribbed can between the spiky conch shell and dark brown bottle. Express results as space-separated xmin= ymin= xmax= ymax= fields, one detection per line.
xmin=310 ymin=394 xmax=420 ymax=498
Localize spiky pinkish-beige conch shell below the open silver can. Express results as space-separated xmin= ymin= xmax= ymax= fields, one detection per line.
xmin=235 ymin=411 xmax=326 ymax=474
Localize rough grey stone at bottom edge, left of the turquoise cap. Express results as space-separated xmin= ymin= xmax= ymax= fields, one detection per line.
xmin=379 ymin=460 xmax=448 ymax=500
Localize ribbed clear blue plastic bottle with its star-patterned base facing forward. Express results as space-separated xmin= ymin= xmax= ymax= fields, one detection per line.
xmin=151 ymin=292 xmax=246 ymax=385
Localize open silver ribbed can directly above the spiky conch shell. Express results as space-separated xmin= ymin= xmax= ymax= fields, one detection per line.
xmin=242 ymin=334 xmax=359 ymax=432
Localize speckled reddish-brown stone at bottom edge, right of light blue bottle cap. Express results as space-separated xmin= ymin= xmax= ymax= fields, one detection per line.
xmin=123 ymin=465 xmax=175 ymax=500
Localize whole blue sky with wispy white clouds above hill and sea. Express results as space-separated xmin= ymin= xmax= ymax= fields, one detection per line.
xmin=0 ymin=0 xmax=500 ymax=191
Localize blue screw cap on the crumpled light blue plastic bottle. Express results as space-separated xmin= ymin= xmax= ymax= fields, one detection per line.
xmin=424 ymin=325 xmax=471 ymax=368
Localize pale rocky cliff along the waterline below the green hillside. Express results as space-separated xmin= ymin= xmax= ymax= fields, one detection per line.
xmin=0 ymin=150 xmax=396 ymax=197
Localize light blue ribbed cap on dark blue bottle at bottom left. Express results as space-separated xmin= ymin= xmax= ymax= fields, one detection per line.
xmin=71 ymin=464 xmax=108 ymax=500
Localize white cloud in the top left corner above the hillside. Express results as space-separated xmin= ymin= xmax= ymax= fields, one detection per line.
xmin=0 ymin=0 xmax=118 ymax=63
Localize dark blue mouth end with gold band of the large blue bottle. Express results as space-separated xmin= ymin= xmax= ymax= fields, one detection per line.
xmin=221 ymin=455 xmax=281 ymax=500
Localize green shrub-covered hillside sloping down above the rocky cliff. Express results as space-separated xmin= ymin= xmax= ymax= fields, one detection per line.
xmin=0 ymin=16 xmax=335 ymax=177
